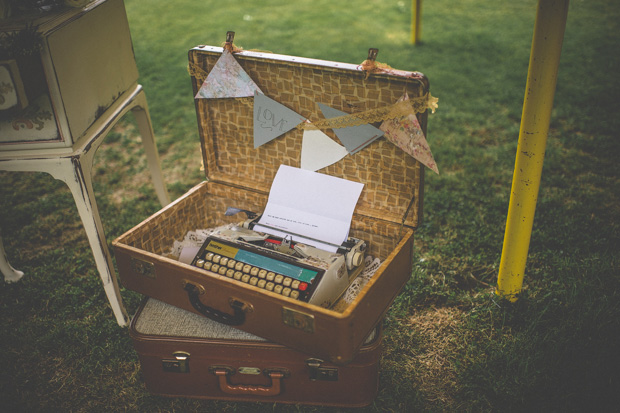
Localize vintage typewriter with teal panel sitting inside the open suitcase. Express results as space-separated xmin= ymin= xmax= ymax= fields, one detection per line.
xmin=192 ymin=219 xmax=366 ymax=308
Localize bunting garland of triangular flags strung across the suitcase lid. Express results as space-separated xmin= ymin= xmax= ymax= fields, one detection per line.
xmin=189 ymin=47 xmax=439 ymax=173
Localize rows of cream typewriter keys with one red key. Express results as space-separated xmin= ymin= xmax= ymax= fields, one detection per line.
xmin=195 ymin=252 xmax=309 ymax=299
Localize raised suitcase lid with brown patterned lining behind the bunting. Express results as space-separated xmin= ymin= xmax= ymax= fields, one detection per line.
xmin=189 ymin=41 xmax=430 ymax=227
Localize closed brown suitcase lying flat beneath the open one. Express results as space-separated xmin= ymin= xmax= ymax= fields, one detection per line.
xmin=129 ymin=298 xmax=381 ymax=407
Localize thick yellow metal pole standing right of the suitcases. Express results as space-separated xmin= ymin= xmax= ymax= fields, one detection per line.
xmin=496 ymin=0 xmax=568 ymax=302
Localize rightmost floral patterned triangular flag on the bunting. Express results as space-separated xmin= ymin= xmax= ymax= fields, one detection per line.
xmin=380 ymin=93 xmax=439 ymax=174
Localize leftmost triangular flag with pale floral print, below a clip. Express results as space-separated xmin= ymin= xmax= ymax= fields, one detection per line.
xmin=195 ymin=49 xmax=262 ymax=99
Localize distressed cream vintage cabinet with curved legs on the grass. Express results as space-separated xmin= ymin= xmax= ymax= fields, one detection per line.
xmin=0 ymin=0 xmax=170 ymax=325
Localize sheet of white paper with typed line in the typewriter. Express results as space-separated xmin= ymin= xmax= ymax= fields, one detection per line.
xmin=254 ymin=165 xmax=364 ymax=252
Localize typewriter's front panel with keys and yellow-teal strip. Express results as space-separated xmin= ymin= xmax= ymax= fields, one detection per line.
xmin=192 ymin=237 xmax=325 ymax=302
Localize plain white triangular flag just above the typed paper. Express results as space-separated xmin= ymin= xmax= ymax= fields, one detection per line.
xmin=300 ymin=130 xmax=348 ymax=172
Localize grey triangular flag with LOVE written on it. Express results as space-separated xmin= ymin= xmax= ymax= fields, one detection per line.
xmin=254 ymin=92 xmax=306 ymax=149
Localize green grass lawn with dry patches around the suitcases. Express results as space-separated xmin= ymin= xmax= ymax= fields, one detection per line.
xmin=0 ymin=0 xmax=620 ymax=412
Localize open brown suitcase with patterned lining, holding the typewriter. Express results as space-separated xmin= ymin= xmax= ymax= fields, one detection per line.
xmin=113 ymin=46 xmax=430 ymax=364
